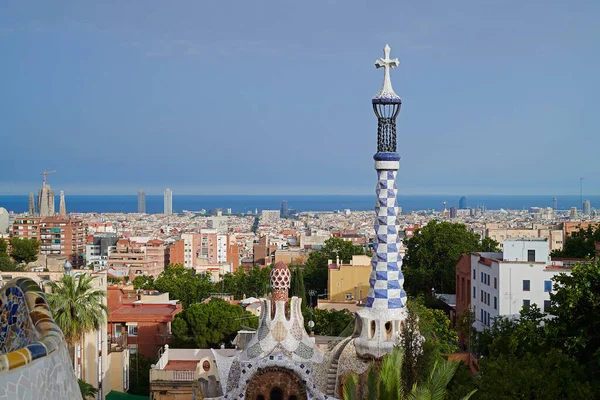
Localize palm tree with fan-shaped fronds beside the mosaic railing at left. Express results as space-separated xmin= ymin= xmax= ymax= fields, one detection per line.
xmin=47 ymin=274 xmax=108 ymax=368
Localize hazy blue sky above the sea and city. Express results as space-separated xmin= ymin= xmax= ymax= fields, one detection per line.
xmin=0 ymin=0 xmax=600 ymax=195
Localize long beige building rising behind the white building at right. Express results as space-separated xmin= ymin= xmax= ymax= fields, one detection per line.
xmin=485 ymin=223 xmax=564 ymax=251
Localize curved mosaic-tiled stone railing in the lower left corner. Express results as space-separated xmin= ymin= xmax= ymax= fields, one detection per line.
xmin=0 ymin=278 xmax=81 ymax=400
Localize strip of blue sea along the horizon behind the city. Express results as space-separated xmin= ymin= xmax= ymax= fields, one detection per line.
xmin=0 ymin=193 xmax=600 ymax=214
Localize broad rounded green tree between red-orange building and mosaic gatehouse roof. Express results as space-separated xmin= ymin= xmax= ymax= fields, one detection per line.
xmin=172 ymin=298 xmax=258 ymax=349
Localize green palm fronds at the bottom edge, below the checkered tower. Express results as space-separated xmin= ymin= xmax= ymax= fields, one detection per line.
xmin=344 ymin=347 xmax=475 ymax=400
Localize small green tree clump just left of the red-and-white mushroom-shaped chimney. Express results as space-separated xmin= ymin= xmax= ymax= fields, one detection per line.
xmin=220 ymin=266 xmax=271 ymax=300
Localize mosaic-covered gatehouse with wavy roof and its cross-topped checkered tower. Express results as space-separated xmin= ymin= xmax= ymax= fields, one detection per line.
xmin=209 ymin=46 xmax=407 ymax=400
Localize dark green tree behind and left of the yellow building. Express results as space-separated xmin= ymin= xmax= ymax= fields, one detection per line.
xmin=304 ymin=237 xmax=365 ymax=294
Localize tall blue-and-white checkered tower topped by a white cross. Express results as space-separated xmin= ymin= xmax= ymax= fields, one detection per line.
xmin=354 ymin=45 xmax=407 ymax=358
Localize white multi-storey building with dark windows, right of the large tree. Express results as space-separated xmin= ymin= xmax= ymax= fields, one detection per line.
xmin=470 ymin=238 xmax=570 ymax=331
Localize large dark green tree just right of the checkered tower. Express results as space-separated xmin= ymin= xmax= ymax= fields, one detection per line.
xmin=403 ymin=220 xmax=498 ymax=295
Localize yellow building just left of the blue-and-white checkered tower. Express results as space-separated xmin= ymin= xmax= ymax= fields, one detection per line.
xmin=327 ymin=256 xmax=372 ymax=303
